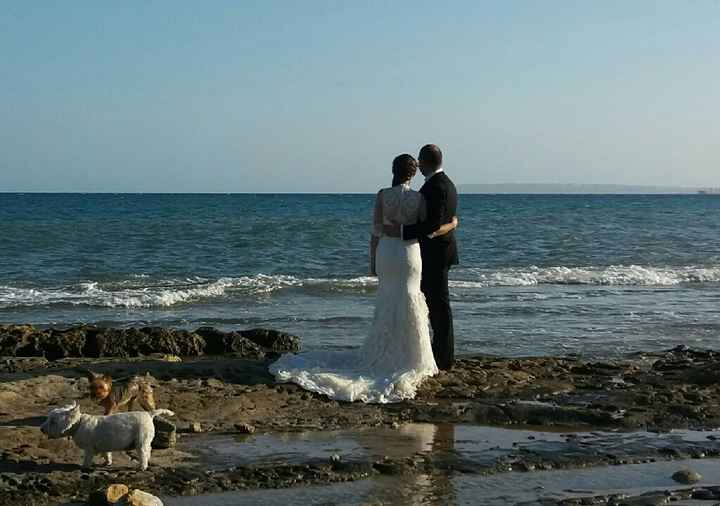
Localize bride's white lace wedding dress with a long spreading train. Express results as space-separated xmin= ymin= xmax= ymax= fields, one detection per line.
xmin=270 ymin=184 xmax=438 ymax=403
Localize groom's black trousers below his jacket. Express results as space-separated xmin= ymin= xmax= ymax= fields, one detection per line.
xmin=420 ymin=263 xmax=455 ymax=370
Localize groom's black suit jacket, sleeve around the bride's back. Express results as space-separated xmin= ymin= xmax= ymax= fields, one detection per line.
xmin=403 ymin=172 xmax=459 ymax=267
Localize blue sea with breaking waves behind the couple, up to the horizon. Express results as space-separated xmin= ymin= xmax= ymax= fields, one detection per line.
xmin=0 ymin=193 xmax=720 ymax=357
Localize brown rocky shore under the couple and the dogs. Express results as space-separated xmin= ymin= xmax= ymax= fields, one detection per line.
xmin=0 ymin=325 xmax=720 ymax=506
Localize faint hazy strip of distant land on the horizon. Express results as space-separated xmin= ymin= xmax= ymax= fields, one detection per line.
xmin=460 ymin=183 xmax=707 ymax=195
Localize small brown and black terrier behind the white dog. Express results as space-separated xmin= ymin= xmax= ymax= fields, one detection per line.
xmin=85 ymin=371 xmax=155 ymax=415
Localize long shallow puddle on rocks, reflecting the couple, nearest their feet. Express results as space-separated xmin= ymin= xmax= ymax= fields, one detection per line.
xmin=188 ymin=424 xmax=720 ymax=469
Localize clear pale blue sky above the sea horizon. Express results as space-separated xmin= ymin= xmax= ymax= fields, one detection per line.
xmin=0 ymin=0 xmax=720 ymax=192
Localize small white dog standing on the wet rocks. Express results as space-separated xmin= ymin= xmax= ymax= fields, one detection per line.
xmin=40 ymin=401 xmax=175 ymax=471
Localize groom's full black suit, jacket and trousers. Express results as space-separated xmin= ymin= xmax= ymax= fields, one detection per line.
xmin=403 ymin=172 xmax=458 ymax=369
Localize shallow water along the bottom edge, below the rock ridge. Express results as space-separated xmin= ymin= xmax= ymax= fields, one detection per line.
xmin=163 ymin=459 xmax=720 ymax=506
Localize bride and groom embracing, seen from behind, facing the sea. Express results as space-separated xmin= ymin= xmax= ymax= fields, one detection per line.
xmin=270 ymin=144 xmax=458 ymax=403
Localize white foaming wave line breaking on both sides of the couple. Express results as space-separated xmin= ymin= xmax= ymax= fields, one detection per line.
xmin=0 ymin=265 xmax=720 ymax=309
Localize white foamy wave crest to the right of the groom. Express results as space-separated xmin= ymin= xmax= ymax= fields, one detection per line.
xmin=451 ymin=265 xmax=720 ymax=289
